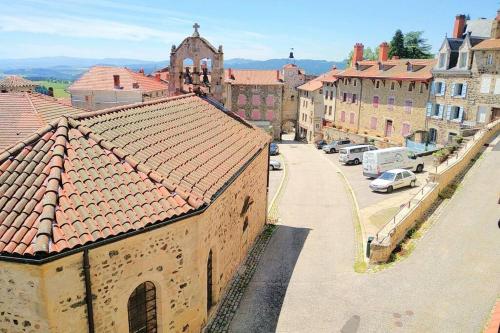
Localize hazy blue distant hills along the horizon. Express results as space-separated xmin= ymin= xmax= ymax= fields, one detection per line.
xmin=0 ymin=57 xmax=345 ymax=80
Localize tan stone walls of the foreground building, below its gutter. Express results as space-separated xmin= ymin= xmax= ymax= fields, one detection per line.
xmin=0 ymin=149 xmax=268 ymax=333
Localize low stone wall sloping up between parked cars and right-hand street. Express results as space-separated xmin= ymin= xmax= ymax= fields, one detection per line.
xmin=370 ymin=120 xmax=500 ymax=263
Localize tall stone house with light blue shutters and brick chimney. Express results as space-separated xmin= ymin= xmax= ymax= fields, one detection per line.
xmin=426 ymin=15 xmax=495 ymax=145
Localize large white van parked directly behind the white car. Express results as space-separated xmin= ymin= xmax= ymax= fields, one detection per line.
xmin=363 ymin=147 xmax=424 ymax=178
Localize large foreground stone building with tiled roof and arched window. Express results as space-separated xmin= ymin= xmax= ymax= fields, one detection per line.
xmin=0 ymin=94 xmax=270 ymax=333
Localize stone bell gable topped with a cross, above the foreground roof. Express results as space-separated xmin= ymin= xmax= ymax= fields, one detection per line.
xmin=169 ymin=23 xmax=224 ymax=101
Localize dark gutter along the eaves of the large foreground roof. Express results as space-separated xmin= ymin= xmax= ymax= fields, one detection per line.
xmin=0 ymin=146 xmax=269 ymax=265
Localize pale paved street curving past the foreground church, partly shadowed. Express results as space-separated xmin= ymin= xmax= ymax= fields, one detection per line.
xmin=231 ymin=134 xmax=500 ymax=333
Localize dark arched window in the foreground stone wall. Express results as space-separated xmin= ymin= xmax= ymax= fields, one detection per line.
xmin=127 ymin=281 xmax=156 ymax=333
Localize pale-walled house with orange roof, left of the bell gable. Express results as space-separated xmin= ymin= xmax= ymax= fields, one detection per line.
xmin=68 ymin=66 xmax=169 ymax=111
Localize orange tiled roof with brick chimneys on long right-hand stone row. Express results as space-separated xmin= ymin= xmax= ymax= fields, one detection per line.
xmin=337 ymin=59 xmax=436 ymax=81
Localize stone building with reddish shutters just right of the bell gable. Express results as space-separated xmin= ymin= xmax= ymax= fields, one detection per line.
xmin=223 ymin=64 xmax=309 ymax=139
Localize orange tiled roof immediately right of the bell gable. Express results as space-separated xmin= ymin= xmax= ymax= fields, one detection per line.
xmin=224 ymin=69 xmax=283 ymax=85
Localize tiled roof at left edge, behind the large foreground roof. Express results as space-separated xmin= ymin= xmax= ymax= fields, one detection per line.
xmin=0 ymin=93 xmax=81 ymax=152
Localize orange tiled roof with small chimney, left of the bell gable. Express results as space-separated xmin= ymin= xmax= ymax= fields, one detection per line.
xmin=68 ymin=66 xmax=168 ymax=92
